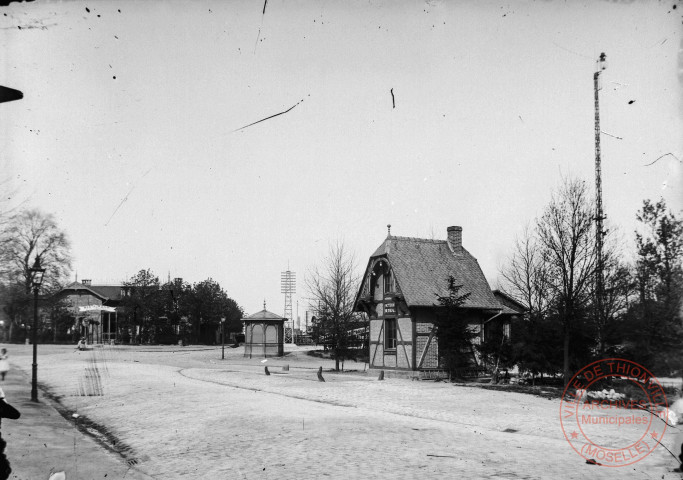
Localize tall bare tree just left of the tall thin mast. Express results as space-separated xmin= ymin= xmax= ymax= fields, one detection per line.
xmin=536 ymin=179 xmax=596 ymax=382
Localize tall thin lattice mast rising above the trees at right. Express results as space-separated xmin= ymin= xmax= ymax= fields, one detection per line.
xmin=593 ymin=52 xmax=607 ymax=334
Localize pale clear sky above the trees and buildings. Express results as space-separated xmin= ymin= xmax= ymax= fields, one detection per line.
xmin=0 ymin=0 xmax=683 ymax=326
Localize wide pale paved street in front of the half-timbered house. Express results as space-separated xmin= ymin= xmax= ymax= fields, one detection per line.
xmin=3 ymin=345 xmax=680 ymax=479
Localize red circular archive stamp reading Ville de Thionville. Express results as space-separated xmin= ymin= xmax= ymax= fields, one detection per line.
xmin=560 ymin=358 xmax=669 ymax=467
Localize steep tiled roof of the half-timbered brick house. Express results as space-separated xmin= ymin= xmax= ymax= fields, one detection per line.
xmin=371 ymin=236 xmax=501 ymax=310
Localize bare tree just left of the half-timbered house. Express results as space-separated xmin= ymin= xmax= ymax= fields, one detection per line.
xmin=306 ymin=242 xmax=360 ymax=371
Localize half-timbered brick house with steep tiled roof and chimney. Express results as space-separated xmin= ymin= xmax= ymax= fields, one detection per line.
xmin=355 ymin=227 xmax=523 ymax=371
